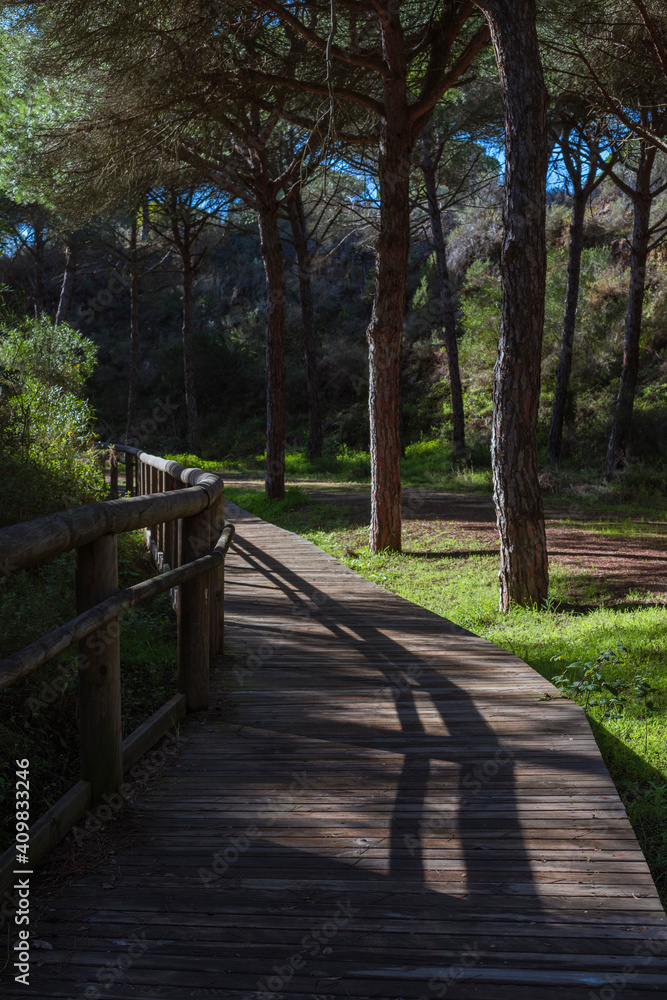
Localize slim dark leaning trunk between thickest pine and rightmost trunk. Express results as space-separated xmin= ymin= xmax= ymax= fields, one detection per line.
xmin=548 ymin=190 xmax=587 ymax=462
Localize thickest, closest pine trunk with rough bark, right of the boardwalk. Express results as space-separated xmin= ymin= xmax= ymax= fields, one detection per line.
xmin=479 ymin=0 xmax=549 ymax=610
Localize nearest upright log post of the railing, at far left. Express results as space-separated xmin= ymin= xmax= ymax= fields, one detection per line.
xmin=76 ymin=535 xmax=123 ymax=801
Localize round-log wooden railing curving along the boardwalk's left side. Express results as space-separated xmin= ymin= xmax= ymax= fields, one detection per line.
xmin=0 ymin=445 xmax=234 ymax=887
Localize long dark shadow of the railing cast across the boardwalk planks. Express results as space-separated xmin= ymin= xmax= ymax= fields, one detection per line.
xmin=230 ymin=536 xmax=540 ymax=909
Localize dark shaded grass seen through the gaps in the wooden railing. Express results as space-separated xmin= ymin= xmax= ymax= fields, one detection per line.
xmin=0 ymin=531 xmax=176 ymax=852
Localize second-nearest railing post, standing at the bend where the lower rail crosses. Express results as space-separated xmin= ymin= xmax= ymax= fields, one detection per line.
xmin=178 ymin=508 xmax=211 ymax=712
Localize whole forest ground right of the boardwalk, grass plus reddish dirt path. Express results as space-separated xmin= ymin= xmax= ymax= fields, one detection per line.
xmin=223 ymin=471 xmax=667 ymax=906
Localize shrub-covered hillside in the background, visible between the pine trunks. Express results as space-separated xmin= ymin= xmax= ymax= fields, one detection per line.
xmin=3 ymin=183 xmax=667 ymax=490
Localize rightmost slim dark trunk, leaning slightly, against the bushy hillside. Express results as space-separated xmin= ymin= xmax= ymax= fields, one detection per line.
xmin=605 ymin=142 xmax=656 ymax=476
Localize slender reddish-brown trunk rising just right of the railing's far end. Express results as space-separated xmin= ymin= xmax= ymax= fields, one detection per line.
xmin=257 ymin=190 xmax=285 ymax=500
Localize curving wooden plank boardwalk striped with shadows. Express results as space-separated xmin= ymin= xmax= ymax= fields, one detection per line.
xmin=3 ymin=505 xmax=667 ymax=1000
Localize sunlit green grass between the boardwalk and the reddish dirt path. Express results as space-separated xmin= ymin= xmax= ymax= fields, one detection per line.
xmin=227 ymin=487 xmax=667 ymax=905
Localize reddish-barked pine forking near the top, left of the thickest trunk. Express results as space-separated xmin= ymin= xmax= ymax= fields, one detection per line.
xmin=366 ymin=0 xmax=489 ymax=552
